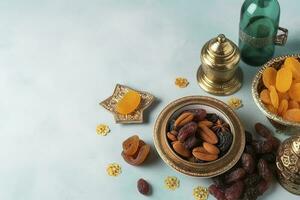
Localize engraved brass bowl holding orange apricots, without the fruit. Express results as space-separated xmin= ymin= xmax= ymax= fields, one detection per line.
xmin=252 ymin=54 xmax=300 ymax=134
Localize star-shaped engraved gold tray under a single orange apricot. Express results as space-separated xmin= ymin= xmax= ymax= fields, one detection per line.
xmin=100 ymin=84 xmax=155 ymax=124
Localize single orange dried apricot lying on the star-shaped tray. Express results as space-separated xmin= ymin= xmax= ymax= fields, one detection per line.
xmin=115 ymin=90 xmax=141 ymax=115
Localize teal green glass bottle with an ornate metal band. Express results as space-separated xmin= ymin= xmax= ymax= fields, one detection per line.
xmin=239 ymin=0 xmax=280 ymax=66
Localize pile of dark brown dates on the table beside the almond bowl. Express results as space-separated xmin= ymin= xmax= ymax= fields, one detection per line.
xmin=209 ymin=123 xmax=280 ymax=200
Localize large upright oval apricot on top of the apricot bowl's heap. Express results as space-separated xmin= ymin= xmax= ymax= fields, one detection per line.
xmin=276 ymin=68 xmax=293 ymax=93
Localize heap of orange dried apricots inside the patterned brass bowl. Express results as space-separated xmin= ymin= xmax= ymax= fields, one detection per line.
xmin=260 ymin=57 xmax=300 ymax=122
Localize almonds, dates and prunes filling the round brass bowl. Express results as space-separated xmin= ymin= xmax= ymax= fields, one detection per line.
xmin=167 ymin=109 xmax=233 ymax=162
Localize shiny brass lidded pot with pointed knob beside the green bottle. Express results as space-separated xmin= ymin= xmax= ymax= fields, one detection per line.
xmin=197 ymin=34 xmax=243 ymax=96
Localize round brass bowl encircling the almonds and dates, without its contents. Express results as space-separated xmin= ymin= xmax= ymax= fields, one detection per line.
xmin=153 ymin=96 xmax=245 ymax=177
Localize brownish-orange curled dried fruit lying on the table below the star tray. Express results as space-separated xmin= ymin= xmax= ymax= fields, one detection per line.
xmin=122 ymin=135 xmax=150 ymax=165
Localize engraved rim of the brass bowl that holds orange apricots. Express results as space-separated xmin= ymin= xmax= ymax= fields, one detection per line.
xmin=252 ymin=54 xmax=300 ymax=128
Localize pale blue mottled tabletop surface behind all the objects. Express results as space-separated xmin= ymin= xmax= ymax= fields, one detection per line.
xmin=0 ymin=0 xmax=300 ymax=200
